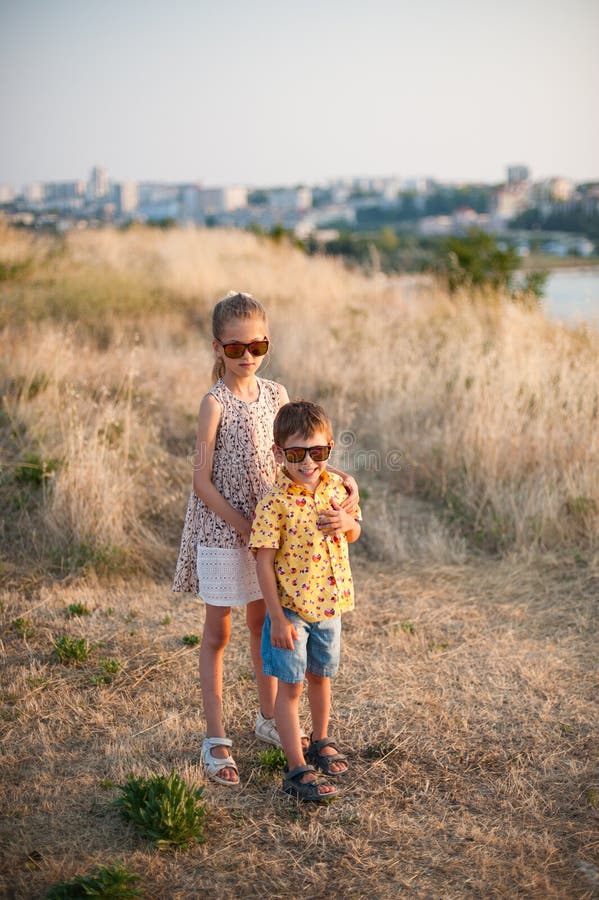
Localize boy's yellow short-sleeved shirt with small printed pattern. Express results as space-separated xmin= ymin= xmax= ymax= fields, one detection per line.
xmin=249 ymin=469 xmax=360 ymax=622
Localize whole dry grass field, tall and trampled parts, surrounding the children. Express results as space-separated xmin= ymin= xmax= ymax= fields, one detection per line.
xmin=0 ymin=223 xmax=599 ymax=900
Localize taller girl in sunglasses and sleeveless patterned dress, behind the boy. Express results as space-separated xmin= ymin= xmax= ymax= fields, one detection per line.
xmin=173 ymin=291 xmax=358 ymax=785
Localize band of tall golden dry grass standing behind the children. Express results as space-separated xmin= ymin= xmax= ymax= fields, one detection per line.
xmin=0 ymin=223 xmax=599 ymax=568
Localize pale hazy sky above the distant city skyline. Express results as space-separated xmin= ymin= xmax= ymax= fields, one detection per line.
xmin=0 ymin=0 xmax=599 ymax=187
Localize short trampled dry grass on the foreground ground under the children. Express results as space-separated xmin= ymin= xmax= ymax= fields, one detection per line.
xmin=1 ymin=558 xmax=599 ymax=898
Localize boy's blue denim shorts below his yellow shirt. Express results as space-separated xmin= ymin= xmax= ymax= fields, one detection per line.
xmin=260 ymin=607 xmax=341 ymax=684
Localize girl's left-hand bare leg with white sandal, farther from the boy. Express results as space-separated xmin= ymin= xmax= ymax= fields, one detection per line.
xmin=200 ymin=603 xmax=238 ymax=781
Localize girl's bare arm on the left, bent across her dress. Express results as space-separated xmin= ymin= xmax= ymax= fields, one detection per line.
xmin=193 ymin=394 xmax=252 ymax=541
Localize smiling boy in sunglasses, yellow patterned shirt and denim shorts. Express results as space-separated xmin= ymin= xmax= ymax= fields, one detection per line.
xmin=249 ymin=400 xmax=360 ymax=803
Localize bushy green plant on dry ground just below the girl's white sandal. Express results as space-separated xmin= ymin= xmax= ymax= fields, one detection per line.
xmin=114 ymin=772 xmax=207 ymax=850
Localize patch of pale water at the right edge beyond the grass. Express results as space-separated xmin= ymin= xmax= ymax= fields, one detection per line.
xmin=543 ymin=269 xmax=599 ymax=326
